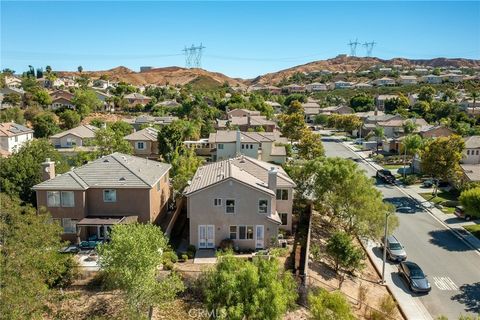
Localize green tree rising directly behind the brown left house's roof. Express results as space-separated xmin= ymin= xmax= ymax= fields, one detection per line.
xmin=93 ymin=128 xmax=133 ymax=157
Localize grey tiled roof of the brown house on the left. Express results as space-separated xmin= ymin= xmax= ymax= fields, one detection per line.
xmin=33 ymin=152 xmax=171 ymax=190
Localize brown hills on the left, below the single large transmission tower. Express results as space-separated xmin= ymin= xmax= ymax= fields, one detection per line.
xmin=58 ymin=66 xmax=244 ymax=87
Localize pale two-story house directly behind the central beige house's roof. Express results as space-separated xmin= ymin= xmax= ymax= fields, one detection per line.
xmin=208 ymin=130 xmax=288 ymax=164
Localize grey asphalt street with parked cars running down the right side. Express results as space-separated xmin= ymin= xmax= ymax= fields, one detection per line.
xmin=322 ymin=137 xmax=480 ymax=320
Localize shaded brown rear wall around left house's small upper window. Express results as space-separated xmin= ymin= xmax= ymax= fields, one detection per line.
xmin=87 ymin=188 xmax=151 ymax=222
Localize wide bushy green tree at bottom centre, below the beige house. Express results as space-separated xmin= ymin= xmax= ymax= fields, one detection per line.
xmin=201 ymin=254 xmax=297 ymax=320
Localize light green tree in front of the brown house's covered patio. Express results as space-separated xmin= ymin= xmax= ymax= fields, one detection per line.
xmin=98 ymin=223 xmax=184 ymax=317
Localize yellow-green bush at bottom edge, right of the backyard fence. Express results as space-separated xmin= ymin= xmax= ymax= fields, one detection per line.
xmin=308 ymin=289 xmax=356 ymax=320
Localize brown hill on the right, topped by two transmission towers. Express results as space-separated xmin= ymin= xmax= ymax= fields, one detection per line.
xmin=249 ymin=55 xmax=480 ymax=84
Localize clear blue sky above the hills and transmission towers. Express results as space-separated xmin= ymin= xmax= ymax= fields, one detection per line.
xmin=0 ymin=0 xmax=480 ymax=78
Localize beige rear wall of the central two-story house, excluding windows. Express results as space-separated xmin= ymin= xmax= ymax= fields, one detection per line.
xmin=187 ymin=180 xmax=278 ymax=249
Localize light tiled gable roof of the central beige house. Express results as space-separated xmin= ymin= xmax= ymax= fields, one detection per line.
xmin=185 ymin=156 xmax=295 ymax=196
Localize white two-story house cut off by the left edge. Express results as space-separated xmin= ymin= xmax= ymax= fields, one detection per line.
xmin=0 ymin=122 xmax=33 ymax=156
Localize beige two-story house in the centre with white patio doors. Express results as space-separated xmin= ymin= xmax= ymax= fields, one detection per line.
xmin=185 ymin=156 xmax=295 ymax=250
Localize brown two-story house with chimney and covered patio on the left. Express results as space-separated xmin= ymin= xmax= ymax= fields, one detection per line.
xmin=33 ymin=152 xmax=171 ymax=243
